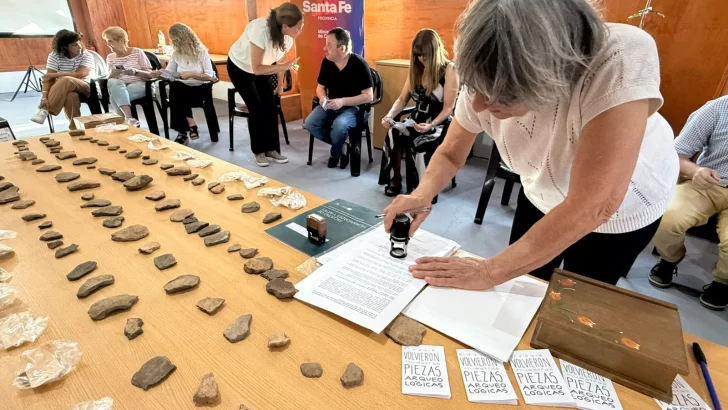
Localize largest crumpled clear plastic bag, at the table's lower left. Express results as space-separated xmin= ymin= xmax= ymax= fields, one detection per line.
xmin=13 ymin=340 xmax=81 ymax=389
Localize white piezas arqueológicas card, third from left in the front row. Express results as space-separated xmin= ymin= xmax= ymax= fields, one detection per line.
xmin=511 ymin=349 xmax=576 ymax=407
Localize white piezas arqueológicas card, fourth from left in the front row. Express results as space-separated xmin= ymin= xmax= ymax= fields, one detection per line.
xmin=561 ymin=359 xmax=622 ymax=410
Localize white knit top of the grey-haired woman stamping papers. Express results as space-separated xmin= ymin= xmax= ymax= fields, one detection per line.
xmin=455 ymin=23 xmax=679 ymax=233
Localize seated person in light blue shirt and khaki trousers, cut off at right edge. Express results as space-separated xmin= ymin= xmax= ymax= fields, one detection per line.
xmin=650 ymin=96 xmax=728 ymax=310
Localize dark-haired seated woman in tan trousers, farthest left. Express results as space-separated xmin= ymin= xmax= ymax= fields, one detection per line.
xmin=30 ymin=30 xmax=94 ymax=130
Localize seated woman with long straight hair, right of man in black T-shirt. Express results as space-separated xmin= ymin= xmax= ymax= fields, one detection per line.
xmin=379 ymin=28 xmax=460 ymax=196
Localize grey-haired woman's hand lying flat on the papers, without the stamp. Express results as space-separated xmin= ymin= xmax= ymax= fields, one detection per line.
xmin=409 ymin=257 xmax=496 ymax=290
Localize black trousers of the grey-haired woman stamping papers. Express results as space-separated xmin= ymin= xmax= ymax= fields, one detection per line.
xmin=510 ymin=188 xmax=662 ymax=285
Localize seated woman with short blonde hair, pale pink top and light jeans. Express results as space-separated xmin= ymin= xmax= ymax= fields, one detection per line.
xmin=101 ymin=26 xmax=159 ymax=127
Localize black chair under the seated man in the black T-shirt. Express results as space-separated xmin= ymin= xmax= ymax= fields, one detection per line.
xmin=307 ymin=68 xmax=384 ymax=177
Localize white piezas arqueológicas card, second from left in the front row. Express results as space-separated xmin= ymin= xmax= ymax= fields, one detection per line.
xmin=457 ymin=349 xmax=518 ymax=405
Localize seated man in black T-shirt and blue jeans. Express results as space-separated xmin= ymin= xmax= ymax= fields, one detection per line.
xmin=303 ymin=27 xmax=374 ymax=169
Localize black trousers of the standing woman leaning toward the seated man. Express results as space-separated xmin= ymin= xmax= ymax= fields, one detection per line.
xmin=227 ymin=59 xmax=281 ymax=155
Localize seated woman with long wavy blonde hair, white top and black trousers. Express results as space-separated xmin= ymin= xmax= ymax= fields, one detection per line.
xmin=167 ymin=23 xmax=216 ymax=144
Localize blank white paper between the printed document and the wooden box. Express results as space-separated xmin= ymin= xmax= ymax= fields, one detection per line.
xmin=402 ymin=276 xmax=547 ymax=362
